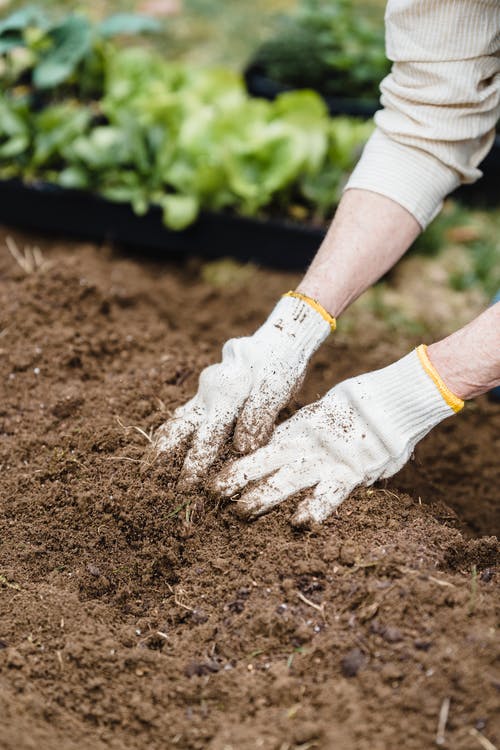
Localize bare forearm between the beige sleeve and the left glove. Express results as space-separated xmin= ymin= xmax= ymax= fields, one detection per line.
xmin=297 ymin=190 xmax=421 ymax=317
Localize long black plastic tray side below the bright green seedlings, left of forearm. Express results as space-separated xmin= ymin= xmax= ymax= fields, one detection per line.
xmin=0 ymin=180 xmax=325 ymax=270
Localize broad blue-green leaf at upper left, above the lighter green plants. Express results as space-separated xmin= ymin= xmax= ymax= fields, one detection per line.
xmin=33 ymin=16 xmax=92 ymax=89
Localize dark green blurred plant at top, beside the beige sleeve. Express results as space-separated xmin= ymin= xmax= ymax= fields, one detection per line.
xmin=251 ymin=0 xmax=390 ymax=98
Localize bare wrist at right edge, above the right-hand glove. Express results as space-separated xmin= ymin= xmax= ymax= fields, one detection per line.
xmin=427 ymin=302 xmax=500 ymax=400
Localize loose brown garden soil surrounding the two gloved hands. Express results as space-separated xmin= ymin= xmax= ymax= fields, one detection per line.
xmin=0 ymin=229 xmax=500 ymax=750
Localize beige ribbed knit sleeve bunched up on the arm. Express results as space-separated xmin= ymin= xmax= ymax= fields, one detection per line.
xmin=346 ymin=0 xmax=500 ymax=227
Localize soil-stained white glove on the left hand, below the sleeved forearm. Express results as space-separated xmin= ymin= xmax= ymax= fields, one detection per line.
xmin=155 ymin=292 xmax=335 ymax=488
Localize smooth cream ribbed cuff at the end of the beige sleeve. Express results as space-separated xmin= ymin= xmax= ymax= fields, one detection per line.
xmin=345 ymin=129 xmax=460 ymax=229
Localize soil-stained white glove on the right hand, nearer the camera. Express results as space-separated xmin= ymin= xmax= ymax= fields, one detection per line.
xmin=213 ymin=345 xmax=463 ymax=526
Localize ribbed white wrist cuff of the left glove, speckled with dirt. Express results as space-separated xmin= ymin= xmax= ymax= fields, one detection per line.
xmin=262 ymin=296 xmax=331 ymax=357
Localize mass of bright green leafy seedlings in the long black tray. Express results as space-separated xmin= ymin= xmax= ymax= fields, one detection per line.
xmin=0 ymin=15 xmax=372 ymax=229
